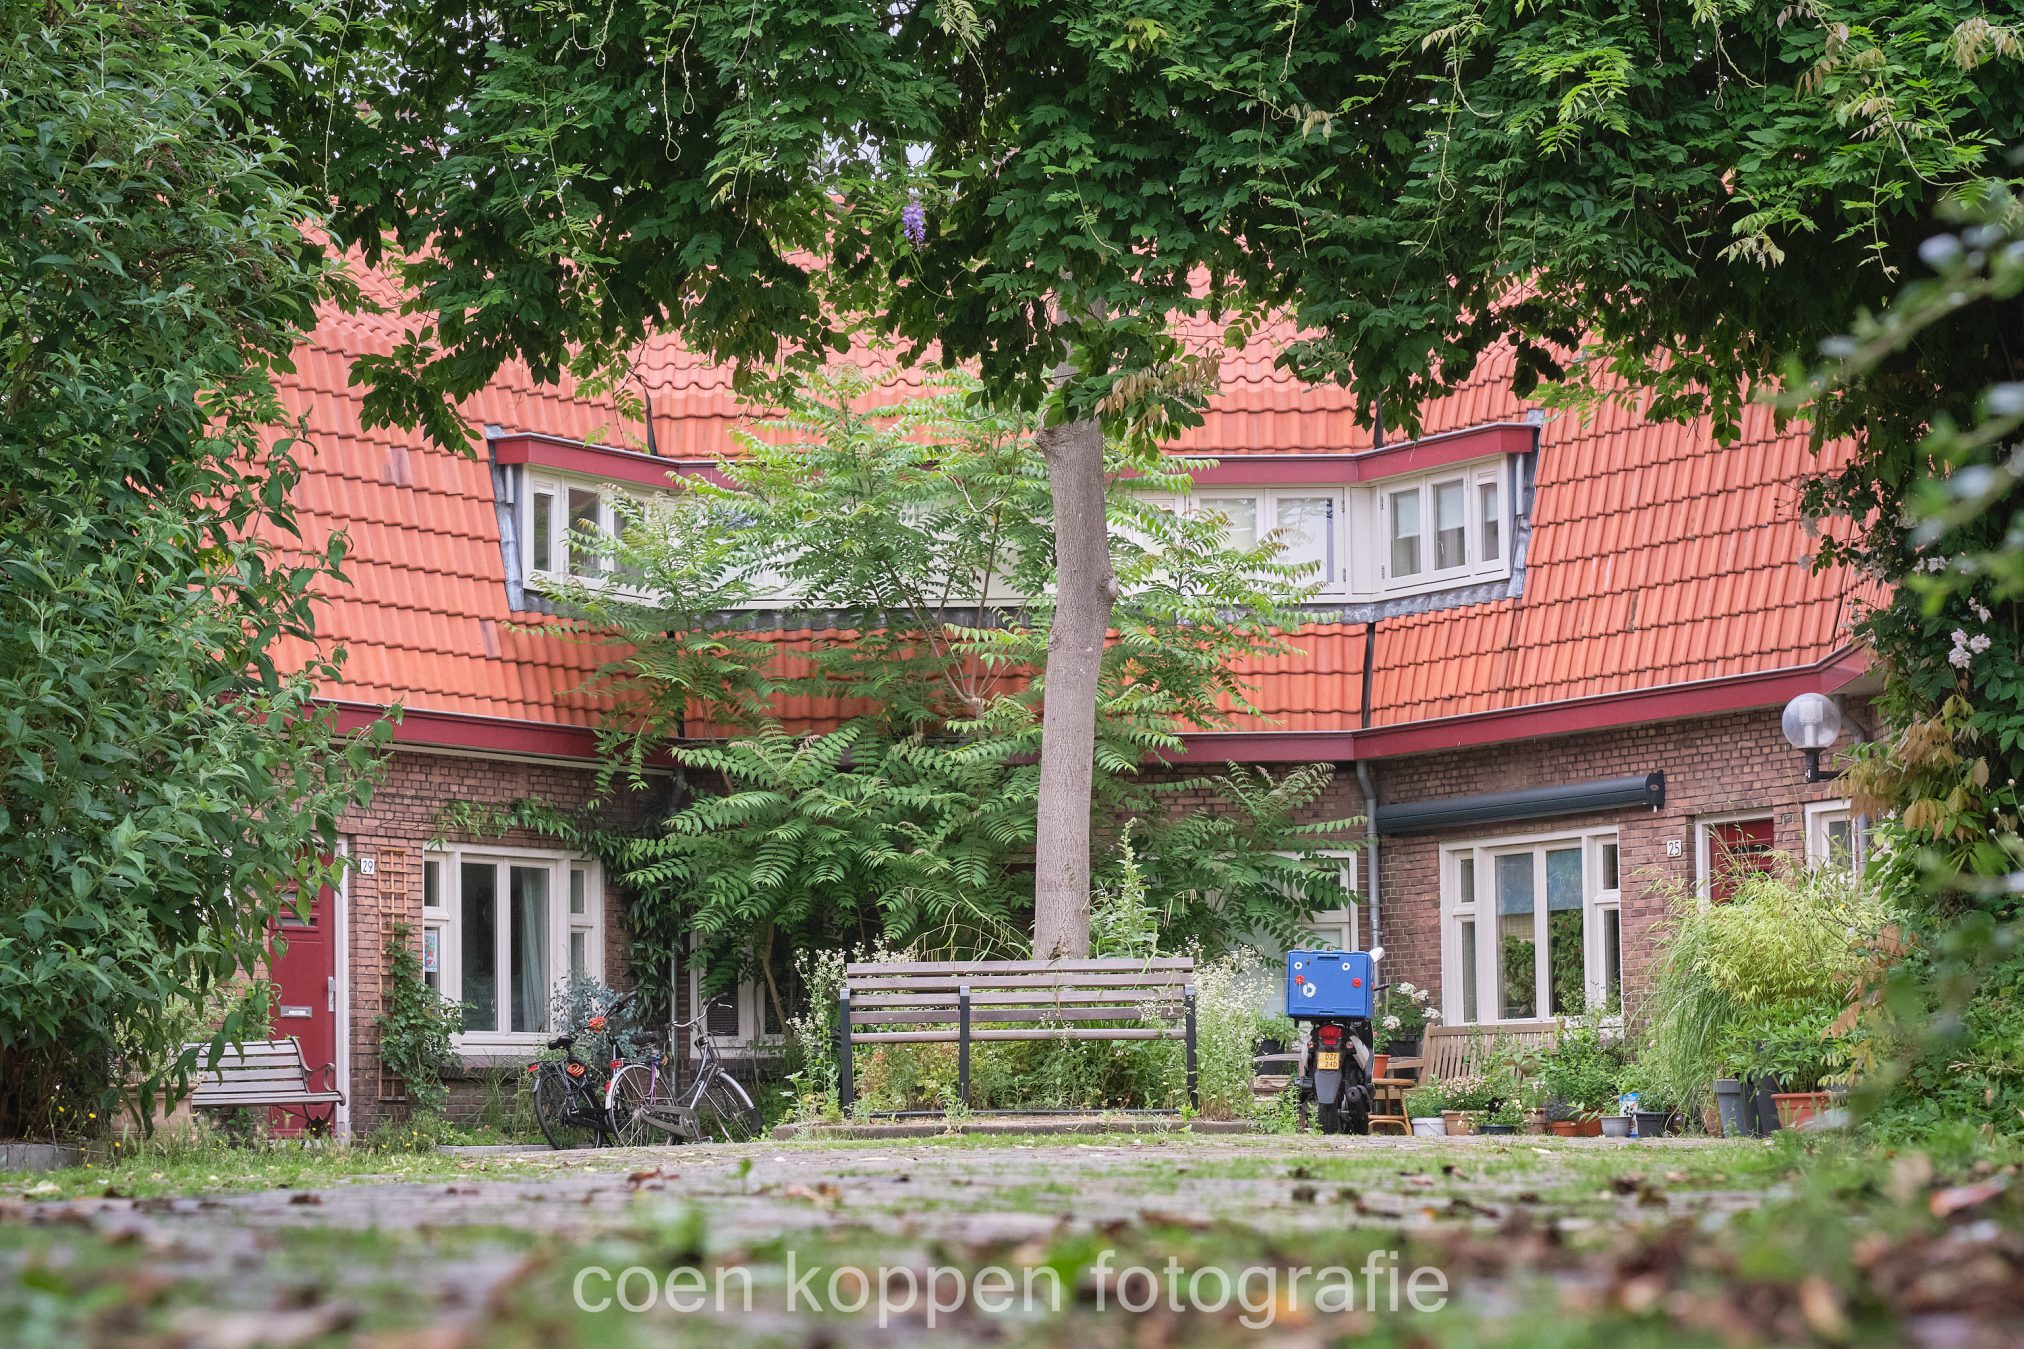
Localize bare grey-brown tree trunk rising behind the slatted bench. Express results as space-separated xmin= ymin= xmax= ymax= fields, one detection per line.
xmin=1032 ymin=421 xmax=1117 ymax=959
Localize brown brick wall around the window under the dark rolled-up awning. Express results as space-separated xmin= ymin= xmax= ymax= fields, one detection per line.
xmin=1180 ymin=708 xmax=1842 ymax=1023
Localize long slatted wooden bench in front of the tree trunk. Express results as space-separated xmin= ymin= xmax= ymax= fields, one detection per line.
xmin=836 ymin=959 xmax=1200 ymax=1114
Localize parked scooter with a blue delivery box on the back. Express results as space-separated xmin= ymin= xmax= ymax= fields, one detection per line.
xmin=1285 ymin=947 xmax=1384 ymax=1133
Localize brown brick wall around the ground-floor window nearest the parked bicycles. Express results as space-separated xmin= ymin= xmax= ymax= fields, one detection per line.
xmin=342 ymin=750 xmax=671 ymax=1133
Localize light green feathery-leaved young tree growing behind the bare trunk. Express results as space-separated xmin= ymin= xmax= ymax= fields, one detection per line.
xmin=546 ymin=372 xmax=1344 ymax=1007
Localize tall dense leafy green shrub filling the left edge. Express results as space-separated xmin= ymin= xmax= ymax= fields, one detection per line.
xmin=0 ymin=0 xmax=382 ymax=1137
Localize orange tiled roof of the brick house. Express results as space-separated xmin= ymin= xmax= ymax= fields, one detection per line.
xmin=265 ymin=277 xmax=1856 ymax=748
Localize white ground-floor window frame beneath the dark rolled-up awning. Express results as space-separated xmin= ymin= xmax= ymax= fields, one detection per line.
xmin=1441 ymin=827 xmax=1623 ymax=1025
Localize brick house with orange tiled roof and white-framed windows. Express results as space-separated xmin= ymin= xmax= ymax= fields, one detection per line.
xmin=265 ymin=295 xmax=1872 ymax=1127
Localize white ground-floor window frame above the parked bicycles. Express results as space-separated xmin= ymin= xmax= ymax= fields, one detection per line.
xmin=421 ymin=843 xmax=605 ymax=1052
